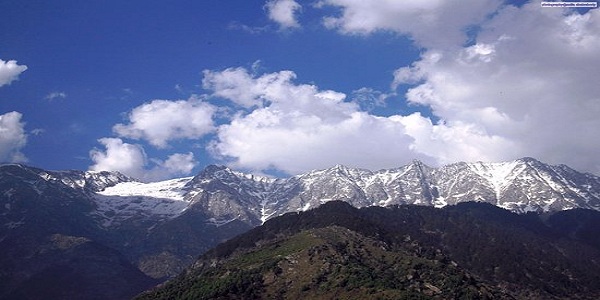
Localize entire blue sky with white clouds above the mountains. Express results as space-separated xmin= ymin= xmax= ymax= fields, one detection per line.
xmin=0 ymin=0 xmax=600 ymax=181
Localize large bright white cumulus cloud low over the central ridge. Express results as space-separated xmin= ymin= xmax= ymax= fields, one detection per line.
xmin=205 ymin=68 xmax=512 ymax=174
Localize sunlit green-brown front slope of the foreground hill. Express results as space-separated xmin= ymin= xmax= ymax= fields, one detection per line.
xmin=141 ymin=225 xmax=511 ymax=299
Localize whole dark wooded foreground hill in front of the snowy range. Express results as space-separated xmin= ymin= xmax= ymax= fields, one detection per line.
xmin=138 ymin=201 xmax=600 ymax=299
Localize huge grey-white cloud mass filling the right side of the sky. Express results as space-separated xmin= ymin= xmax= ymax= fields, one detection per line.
xmin=392 ymin=3 xmax=600 ymax=173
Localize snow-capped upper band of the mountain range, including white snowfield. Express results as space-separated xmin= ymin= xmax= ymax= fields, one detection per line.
xmin=9 ymin=158 xmax=600 ymax=226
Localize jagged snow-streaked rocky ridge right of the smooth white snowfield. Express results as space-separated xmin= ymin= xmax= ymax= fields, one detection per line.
xmin=81 ymin=158 xmax=600 ymax=229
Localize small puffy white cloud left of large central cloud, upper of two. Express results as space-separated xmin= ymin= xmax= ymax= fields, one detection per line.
xmin=113 ymin=97 xmax=215 ymax=148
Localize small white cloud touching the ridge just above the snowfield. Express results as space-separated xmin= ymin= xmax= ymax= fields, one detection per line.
xmin=89 ymin=138 xmax=198 ymax=181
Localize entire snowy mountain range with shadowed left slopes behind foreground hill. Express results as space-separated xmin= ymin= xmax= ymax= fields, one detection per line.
xmin=0 ymin=158 xmax=600 ymax=299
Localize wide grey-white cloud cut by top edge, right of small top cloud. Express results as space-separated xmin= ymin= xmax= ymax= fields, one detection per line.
xmin=317 ymin=0 xmax=502 ymax=47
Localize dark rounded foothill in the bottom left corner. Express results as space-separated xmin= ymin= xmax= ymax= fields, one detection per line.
xmin=0 ymin=234 xmax=158 ymax=300
